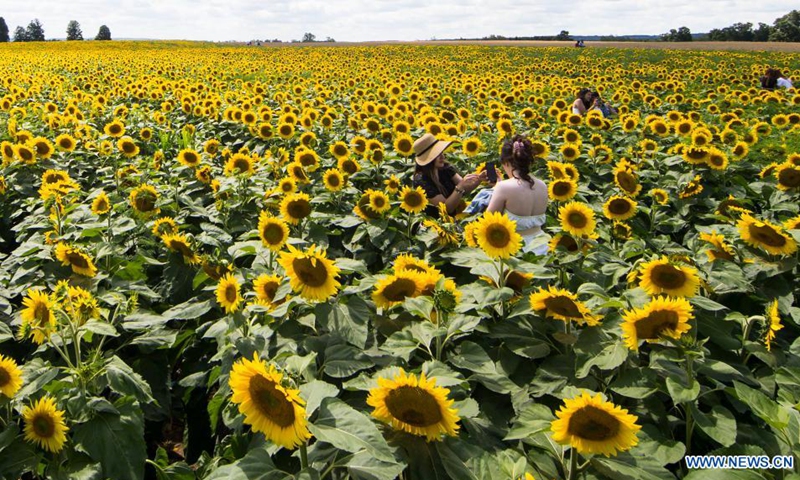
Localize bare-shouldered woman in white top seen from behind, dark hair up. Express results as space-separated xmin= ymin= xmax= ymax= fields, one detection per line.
xmin=486 ymin=135 xmax=548 ymax=255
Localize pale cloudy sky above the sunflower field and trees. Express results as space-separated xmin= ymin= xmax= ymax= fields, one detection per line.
xmin=0 ymin=0 xmax=797 ymax=41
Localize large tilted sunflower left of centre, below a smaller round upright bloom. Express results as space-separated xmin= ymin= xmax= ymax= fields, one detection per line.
xmin=278 ymin=245 xmax=341 ymax=301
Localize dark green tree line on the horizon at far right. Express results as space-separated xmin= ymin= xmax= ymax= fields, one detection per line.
xmin=661 ymin=10 xmax=800 ymax=42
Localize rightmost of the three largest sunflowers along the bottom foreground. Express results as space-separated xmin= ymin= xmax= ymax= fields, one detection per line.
xmin=550 ymin=392 xmax=642 ymax=457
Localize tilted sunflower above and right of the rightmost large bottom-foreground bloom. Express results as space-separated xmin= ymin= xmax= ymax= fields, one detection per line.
xmin=622 ymin=297 xmax=694 ymax=351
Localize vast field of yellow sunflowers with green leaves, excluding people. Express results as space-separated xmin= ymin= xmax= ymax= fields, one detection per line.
xmin=0 ymin=42 xmax=800 ymax=480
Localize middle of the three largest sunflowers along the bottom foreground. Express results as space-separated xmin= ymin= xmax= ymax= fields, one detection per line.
xmin=367 ymin=369 xmax=460 ymax=442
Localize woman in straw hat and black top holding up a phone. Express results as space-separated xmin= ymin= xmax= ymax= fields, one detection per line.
xmin=414 ymin=133 xmax=486 ymax=217
